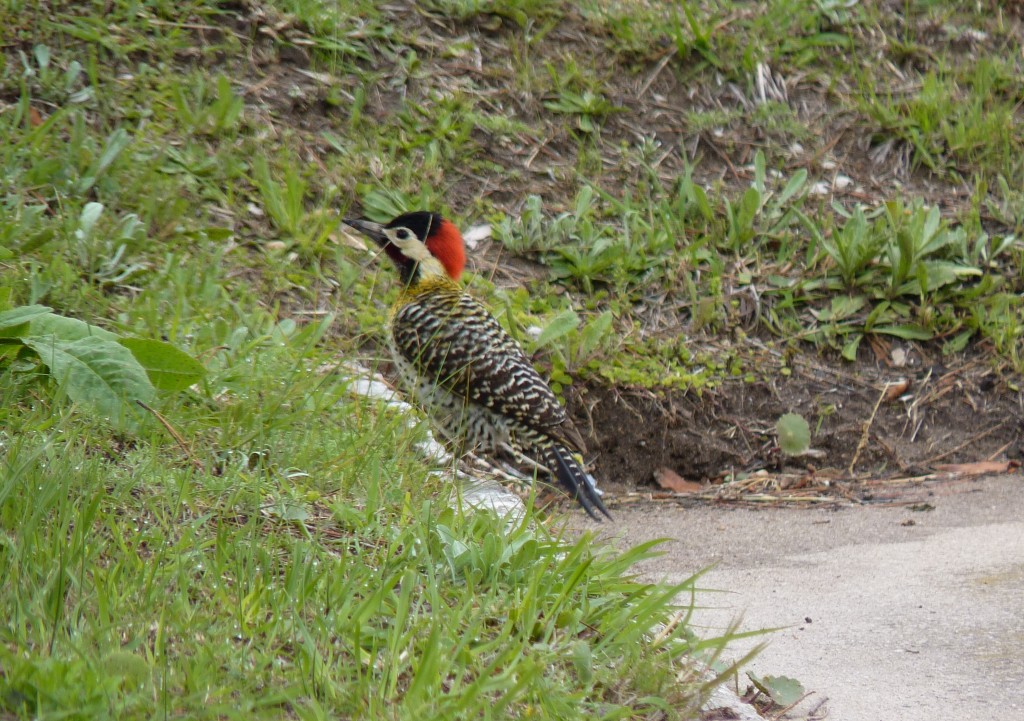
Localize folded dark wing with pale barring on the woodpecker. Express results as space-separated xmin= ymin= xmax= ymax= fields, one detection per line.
xmin=391 ymin=290 xmax=584 ymax=451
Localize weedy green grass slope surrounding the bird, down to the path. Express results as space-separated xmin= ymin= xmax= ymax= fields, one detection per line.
xmin=0 ymin=0 xmax=1024 ymax=719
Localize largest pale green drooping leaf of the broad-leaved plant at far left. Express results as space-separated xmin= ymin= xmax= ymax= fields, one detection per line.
xmin=25 ymin=335 xmax=156 ymax=430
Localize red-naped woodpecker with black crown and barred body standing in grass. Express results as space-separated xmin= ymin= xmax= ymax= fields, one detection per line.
xmin=345 ymin=211 xmax=611 ymax=520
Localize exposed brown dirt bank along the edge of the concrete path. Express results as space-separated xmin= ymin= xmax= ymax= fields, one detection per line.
xmin=572 ymin=348 xmax=1024 ymax=493
